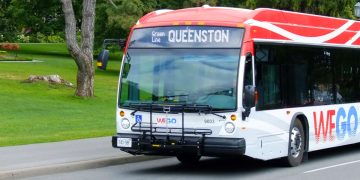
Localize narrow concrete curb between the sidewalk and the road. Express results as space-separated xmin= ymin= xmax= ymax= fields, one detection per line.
xmin=0 ymin=155 xmax=166 ymax=179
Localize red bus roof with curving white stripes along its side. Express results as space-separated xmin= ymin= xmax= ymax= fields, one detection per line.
xmin=134 ymin=5 xmax=360 ymax=48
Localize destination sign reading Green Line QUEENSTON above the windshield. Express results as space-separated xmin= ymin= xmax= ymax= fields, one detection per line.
xmin=129 ymin=26 xmax=244 ymax=48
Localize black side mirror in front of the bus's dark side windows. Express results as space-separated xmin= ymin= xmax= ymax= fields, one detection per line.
xmin=243 ymin=85 xmax=256 ymax=120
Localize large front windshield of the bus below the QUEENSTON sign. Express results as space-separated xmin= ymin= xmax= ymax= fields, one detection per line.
xmin=119 ymin=26 xmax=242 ymax=111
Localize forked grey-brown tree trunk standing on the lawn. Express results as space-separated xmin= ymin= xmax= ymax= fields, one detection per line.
xmin=61 ymin=0 xmax=96 ymax=97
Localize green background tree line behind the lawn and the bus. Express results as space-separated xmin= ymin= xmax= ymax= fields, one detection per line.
xmin=0 ymin=0 xmax=356 ymax=47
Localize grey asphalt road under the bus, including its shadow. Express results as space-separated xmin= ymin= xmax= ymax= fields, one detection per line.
xmin=25 ymin=144 xmax=360 ymax=180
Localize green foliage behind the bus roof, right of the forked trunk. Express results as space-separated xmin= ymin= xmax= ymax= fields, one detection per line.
xmin=95 ymin=0 xmax=356 ymax=46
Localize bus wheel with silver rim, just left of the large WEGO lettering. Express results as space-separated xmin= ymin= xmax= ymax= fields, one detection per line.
xmin=284 ymin=119 xmax=306 ymax=167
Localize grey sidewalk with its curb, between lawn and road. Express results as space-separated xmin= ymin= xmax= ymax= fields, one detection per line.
xmin=0 ymin=137 xmax=156 ymax=179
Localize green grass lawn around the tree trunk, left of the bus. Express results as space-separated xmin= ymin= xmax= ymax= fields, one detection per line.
xmin=0 ymin=44 xmax=120 ymax=146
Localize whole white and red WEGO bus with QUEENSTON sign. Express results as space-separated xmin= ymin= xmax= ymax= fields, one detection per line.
xmin=112 ymin=6 xmax=360 ymax=166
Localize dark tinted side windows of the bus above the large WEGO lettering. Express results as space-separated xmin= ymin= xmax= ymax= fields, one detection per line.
xmin=255 ymin=44 xmax=360 ymax=110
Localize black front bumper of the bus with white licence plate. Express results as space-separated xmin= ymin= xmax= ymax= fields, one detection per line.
xmin=112 ymin=134 xmax=246 ymax=156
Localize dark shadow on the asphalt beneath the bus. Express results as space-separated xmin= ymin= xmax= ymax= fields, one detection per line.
xmin=132 ymin=144 xmax=360 ymax=177
